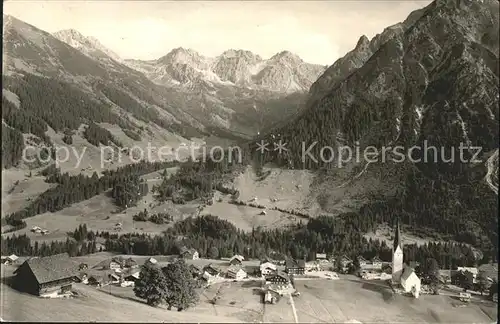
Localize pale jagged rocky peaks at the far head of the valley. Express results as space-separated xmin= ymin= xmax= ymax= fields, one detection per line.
xmin=126 ymin=48 xmax=325 ymax=94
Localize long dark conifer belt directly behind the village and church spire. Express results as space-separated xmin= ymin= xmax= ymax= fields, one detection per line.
xmin=100 ymin=216 xmax=485 ymax=268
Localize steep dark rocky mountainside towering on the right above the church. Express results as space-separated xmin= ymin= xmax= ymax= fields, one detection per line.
xmin=256 ymin=0 xmax=499 ymax=252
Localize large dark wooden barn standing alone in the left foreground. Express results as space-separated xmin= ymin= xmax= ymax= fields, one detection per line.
xmin=14 ymin=254 xmax=78 ymax=296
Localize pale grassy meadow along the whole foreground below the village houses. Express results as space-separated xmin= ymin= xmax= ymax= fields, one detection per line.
xmin=1 ymin=260 xmax=497 ymax=323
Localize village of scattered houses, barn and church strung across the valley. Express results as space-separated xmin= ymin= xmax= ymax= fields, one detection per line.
xmin=2 ymin=221 xmax=498 ymax=323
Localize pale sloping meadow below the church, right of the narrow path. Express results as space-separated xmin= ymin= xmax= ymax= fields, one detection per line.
xmin=294 ymin=279 xmax=496 ymax=323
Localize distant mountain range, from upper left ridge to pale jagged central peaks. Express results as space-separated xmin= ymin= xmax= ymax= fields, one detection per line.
xmin=3 ymin=15 xmax=325 ymax=142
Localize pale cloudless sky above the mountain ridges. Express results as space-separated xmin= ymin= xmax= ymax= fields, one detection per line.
xmin=3 ymin=0 xmax=431 ymax=65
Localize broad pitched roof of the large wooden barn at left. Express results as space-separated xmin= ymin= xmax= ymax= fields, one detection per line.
xmin=17 ymin=253 xmax=78 ymax=284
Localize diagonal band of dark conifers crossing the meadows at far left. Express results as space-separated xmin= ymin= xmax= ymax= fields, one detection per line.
xmin=5 ymin=162 xmax=177 ymax=226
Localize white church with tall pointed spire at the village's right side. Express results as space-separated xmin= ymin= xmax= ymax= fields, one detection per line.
xmin=392 ymin=220 xmax=421 ymax=298
